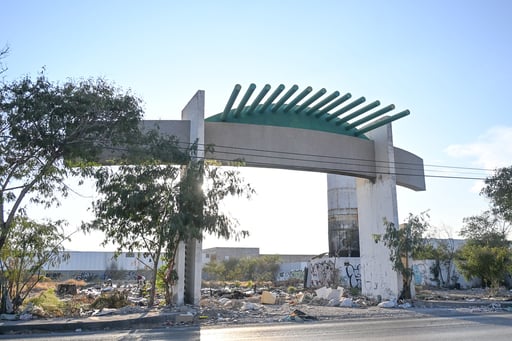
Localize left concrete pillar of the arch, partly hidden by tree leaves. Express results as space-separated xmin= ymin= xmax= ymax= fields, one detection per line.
xmin=175 ymin=90 xmax=204 ymax=305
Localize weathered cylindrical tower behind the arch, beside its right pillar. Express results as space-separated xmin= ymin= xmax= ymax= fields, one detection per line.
xmin=327 ymin=174 xmax=359 ymax=257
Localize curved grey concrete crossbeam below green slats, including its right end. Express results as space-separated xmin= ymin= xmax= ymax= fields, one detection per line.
xmin=205 ymin=121 xmax=425 ymax=191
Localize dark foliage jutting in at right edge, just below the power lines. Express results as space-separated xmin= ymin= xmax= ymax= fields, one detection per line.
xmin=481 ymin=166 xmax=512 ymax=223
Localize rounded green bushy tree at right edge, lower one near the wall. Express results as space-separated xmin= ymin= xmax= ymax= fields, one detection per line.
xmin=456 ymin=211 xmax=512 ymax=289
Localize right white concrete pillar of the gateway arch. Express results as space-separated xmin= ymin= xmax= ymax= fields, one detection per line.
xmin=356 ymin=124 xmax=402 ymax=299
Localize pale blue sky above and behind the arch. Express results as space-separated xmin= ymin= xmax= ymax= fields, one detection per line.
xmin=0 ymin=0 xmax=512 ymax=254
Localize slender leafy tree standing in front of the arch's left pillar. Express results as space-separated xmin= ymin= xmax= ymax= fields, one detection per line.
xmin=84 ymin=139 xmax=253 ymax=305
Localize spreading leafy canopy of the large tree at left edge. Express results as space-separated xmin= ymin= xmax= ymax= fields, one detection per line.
xmin=0 ymin=73 xmax=142 ymax=250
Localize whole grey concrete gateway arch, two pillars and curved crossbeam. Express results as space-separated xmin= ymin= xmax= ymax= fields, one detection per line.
xmin=157 ymin=87 xmax=425 ymax=304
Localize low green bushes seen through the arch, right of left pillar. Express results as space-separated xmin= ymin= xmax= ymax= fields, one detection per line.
xmin=203 ymin=255 xmax=280 ymax=282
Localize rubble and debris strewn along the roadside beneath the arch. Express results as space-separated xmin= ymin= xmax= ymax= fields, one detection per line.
xmin=0 ymin=282 xmax=512 ymax=325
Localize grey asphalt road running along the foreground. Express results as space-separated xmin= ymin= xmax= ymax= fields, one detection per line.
xmin=4 ymin=313 xmax=512 ymax=341
